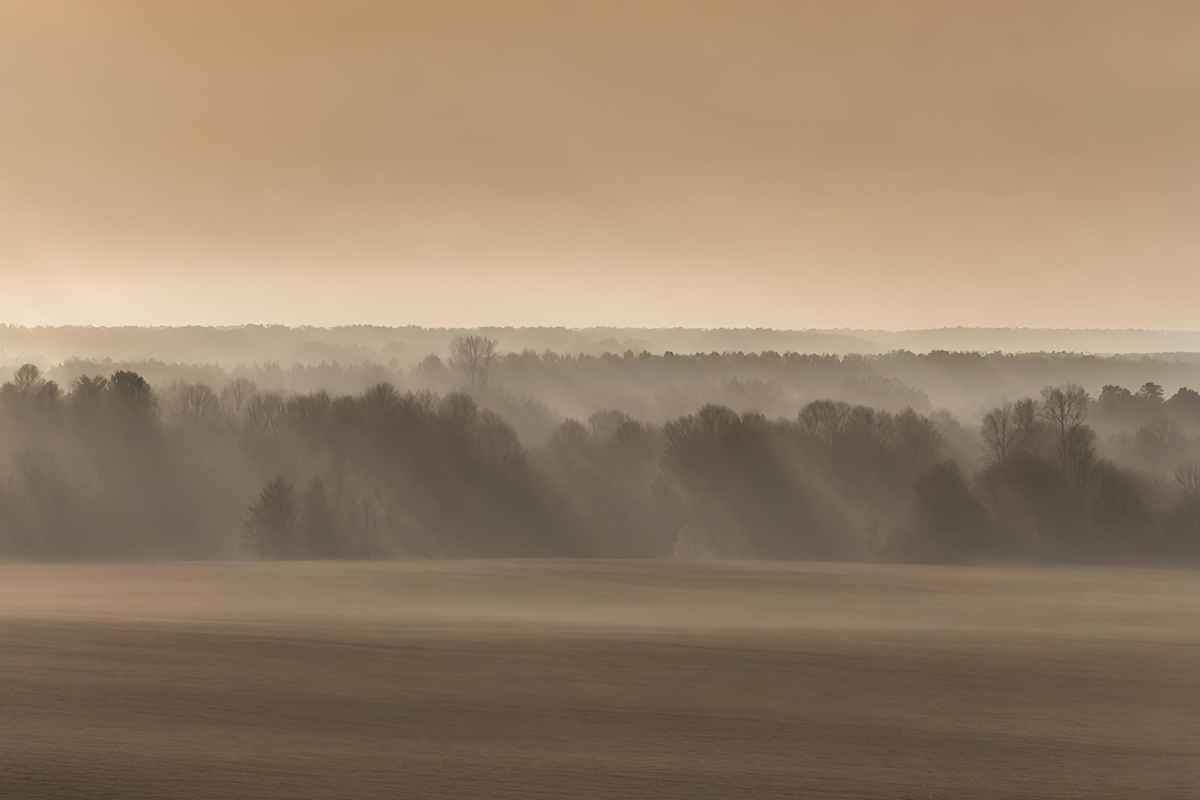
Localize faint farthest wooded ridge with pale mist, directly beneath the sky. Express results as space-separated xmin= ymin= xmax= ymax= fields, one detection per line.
xmin=0 ymin=324 xmax=1200 ymax=365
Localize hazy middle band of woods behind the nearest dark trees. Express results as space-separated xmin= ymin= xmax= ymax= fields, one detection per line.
xmin=16 ymin=345 xmax=1200 ymax=431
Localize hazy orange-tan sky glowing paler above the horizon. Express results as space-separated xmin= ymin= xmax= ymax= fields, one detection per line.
xmin=0 ymin=0 xmax=1200 ymax=330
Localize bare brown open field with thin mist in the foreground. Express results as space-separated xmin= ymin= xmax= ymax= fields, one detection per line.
xmin=0 ymin=561 xmax=1200 ymax=800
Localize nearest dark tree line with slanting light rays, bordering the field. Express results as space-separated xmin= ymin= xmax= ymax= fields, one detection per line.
xmin=0 ymin=347 xmax=1200 ymax=563
